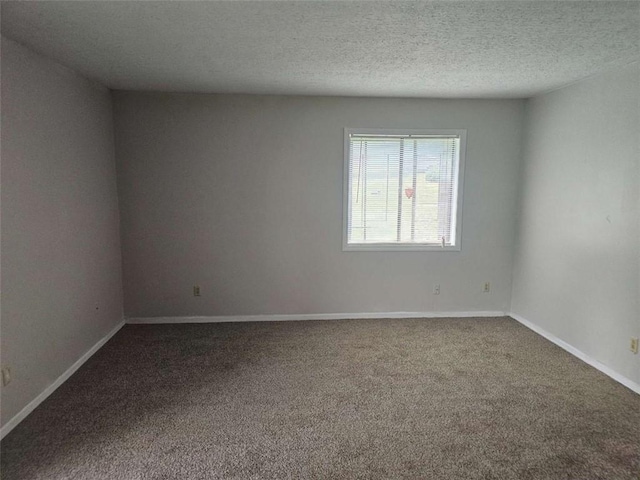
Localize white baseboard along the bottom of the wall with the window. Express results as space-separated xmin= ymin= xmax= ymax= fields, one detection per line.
xmin=126 ymin=312 xmax=506 ymax=324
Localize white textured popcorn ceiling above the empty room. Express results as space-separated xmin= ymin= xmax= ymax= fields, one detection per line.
xmin=2 ymin=0 xmax=640 ymax=98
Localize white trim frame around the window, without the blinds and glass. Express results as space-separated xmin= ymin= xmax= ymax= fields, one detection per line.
xmin=342 ymin=128 xmax=467 ymax=252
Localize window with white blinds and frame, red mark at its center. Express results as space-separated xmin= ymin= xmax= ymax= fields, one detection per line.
xmin=343 ymin=129 xmax=466 ymax=250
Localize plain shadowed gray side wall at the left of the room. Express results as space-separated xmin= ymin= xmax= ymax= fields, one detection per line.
xmin=1 ymin=38 xmax=123 ymax=425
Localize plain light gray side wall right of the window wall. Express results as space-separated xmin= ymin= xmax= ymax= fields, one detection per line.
xmin=512 ymin=63 xmax=640 ymax=382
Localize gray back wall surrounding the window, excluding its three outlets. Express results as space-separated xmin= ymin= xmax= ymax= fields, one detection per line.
xmin=114 ymin=92 xmax=524 ymax=317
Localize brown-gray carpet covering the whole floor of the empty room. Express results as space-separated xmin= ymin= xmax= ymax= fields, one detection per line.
xmin=0 ymin=318 xmax=640 ymax=480
